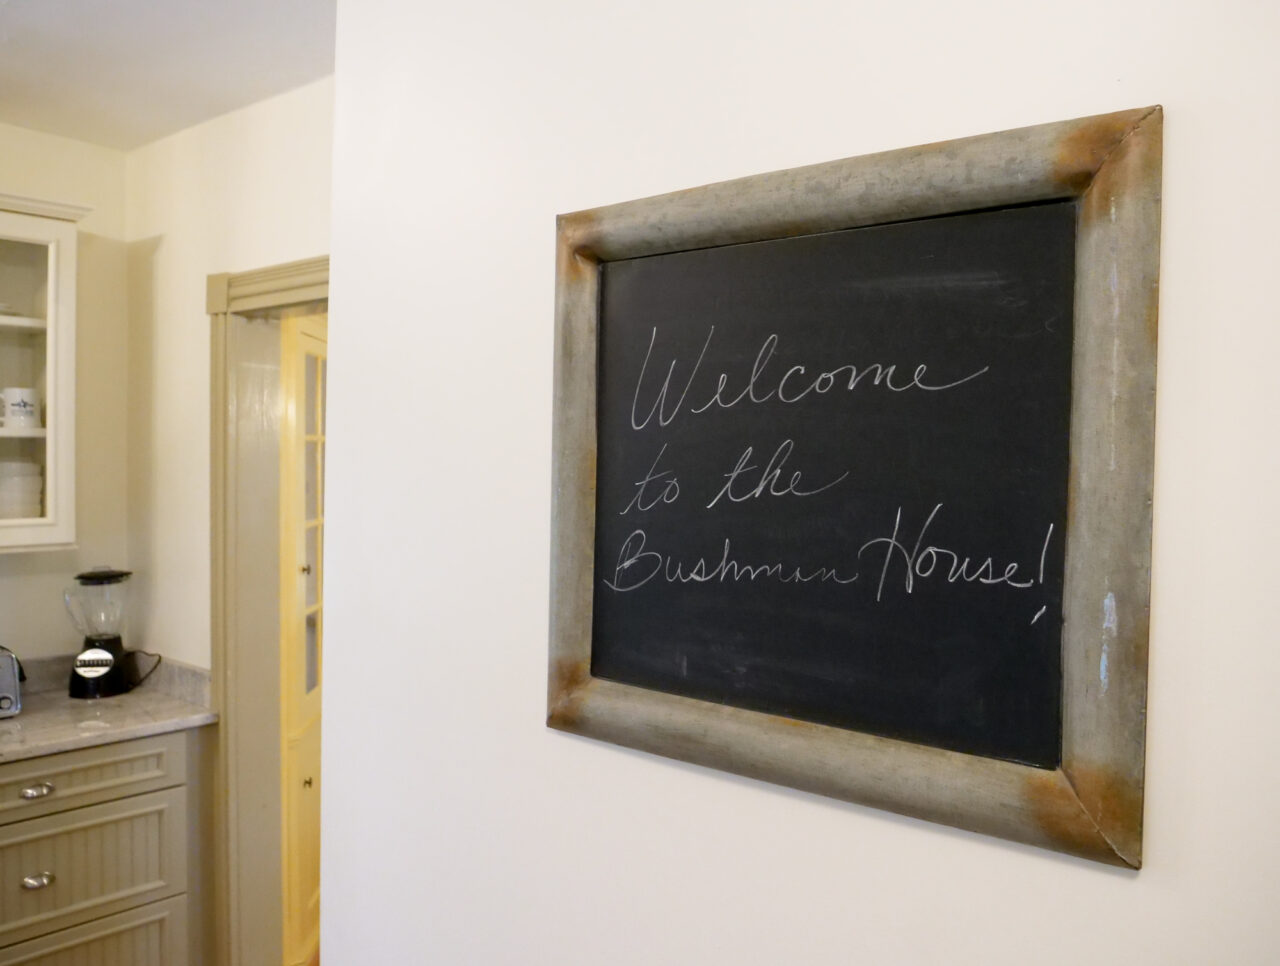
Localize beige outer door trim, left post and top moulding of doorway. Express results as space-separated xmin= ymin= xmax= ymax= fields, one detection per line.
xmin=206 ymin=255 xmax=329 ymax=966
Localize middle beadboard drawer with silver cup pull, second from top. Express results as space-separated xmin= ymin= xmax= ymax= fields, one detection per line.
xmin=0 ymin=788 xmax=187 ymax=946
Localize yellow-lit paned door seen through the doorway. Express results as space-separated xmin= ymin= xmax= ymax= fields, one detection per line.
xmin=280 ymin=313 xmax=328 ymax=966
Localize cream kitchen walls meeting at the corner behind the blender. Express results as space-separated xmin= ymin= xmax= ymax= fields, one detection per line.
xmin=0 ymin=79 xmax=333 ymax=667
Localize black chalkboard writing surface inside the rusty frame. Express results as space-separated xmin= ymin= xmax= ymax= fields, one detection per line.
xmin=591 ymin=201 xmax=1076 ymax=768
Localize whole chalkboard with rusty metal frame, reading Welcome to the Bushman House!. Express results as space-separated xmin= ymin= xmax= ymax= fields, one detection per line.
xmin=548 ymin=107 xmax=1161 ymax=867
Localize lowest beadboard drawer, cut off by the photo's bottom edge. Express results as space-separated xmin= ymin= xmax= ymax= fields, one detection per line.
xmin=0 ymin=896 xmax=187 ymax=966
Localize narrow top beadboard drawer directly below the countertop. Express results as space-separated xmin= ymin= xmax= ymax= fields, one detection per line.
xmin=0 ymin=732 xmax=187 ymax=825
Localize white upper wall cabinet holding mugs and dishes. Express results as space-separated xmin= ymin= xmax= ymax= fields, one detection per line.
xmin=0 ymin=194 xmax=86 ymax=553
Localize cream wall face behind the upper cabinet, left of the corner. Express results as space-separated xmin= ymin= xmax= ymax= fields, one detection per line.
xmin=0 ymin=124 xmax=128 ymax=658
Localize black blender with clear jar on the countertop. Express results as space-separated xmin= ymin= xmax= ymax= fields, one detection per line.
xmin=63 ymin=567 xmax=148 ymax=697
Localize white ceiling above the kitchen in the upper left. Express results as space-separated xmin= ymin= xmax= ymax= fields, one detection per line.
xmin=0 ymin=0 xmax=337 ymax=150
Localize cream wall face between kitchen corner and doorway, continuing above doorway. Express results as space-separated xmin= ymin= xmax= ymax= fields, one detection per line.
xmin=125 ymin=78 xmax=333 ymax=667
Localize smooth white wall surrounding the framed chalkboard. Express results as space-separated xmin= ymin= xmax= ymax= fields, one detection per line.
xmin=323 ymin=0 xmax=1280 ymax=966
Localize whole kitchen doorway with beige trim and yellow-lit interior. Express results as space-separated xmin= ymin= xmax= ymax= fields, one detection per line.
xmin=209 ymin=258 xmax=328 ymax=966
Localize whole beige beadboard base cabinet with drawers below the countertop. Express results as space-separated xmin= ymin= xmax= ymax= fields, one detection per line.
xmin=0 ymin=732 xmax=206 ymax=966
